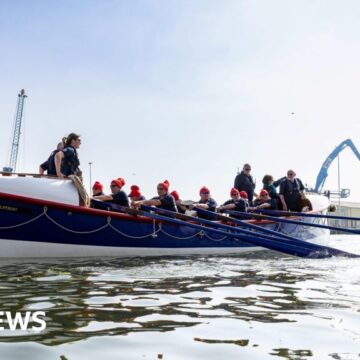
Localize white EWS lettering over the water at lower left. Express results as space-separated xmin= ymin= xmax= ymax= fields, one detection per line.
xmin=0 ymin=311 xmax=46 ymax=332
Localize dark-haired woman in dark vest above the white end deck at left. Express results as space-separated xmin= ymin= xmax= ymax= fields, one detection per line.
xmin=55 ymin=133 xmax=81 ymax=179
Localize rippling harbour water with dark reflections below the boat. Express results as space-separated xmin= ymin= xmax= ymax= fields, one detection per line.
xmin=0 ymin=236 xmax=360 ymax=360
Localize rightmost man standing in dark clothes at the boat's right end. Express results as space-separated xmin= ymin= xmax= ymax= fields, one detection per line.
xmin=279 ymin=170 xmax=305 ymax=211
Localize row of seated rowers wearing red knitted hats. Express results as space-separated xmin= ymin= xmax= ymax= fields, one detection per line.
xmin=92 ymin=178 xmax=278 ymax=218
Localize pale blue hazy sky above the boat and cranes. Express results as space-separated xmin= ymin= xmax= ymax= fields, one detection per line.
xmin=0 ymin=0 xmax=360 ymax=202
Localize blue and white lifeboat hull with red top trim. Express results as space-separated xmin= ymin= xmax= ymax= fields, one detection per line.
xmin=0 ymin=193 xmax=326 ymax=258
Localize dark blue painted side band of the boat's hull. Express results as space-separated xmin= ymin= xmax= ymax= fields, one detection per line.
xmin=0 ymin=200 xmax=253 ymax=248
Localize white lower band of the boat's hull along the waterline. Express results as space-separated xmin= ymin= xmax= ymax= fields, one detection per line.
xmin=0 ymin=239 xmax=265 ymax=258
